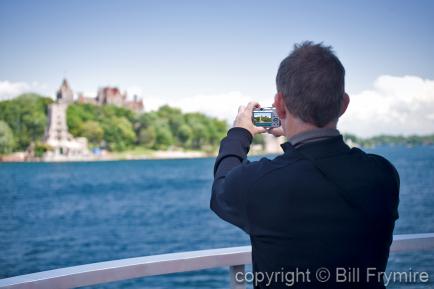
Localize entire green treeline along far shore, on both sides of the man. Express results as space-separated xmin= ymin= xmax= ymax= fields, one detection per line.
xmin=0 ymin=93 xmax=434 ymax=154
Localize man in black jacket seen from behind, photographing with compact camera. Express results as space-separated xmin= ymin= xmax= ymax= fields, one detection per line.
xmin=211 ymin=42 xmax=399 ymax=288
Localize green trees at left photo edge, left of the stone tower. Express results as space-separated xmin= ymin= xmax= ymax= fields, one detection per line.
xmin=0 ymin=93 xmax=53 ymax=151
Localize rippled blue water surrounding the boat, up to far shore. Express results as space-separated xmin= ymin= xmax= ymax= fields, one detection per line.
xmin=0 ymin=147 xmax=434 ymax=288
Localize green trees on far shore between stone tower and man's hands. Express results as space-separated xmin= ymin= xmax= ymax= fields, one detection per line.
xmin=67 ymin=103 xmax=228 ymax=151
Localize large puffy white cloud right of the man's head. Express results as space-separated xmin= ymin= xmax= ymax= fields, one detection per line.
xmin=339 ymin=75 xmax=434 ymax=136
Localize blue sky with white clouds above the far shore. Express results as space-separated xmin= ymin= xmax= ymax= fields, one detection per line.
xmin=0 ymin=0 xmax=434 ymax=136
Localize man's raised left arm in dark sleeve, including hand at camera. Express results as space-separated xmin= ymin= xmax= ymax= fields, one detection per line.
xmin=210 ymin=103 xmax=263 ymax=233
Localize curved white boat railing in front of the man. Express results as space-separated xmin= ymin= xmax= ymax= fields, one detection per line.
xmin=0 ymin=233 xmax=434 ymax=289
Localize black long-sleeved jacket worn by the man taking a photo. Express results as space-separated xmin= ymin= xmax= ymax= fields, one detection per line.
xmin=211 ymin=128 xmax=399 ymax=288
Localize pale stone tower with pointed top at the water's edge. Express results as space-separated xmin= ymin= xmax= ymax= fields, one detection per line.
xmin=44 ymin=79 xmax=89 ymax=161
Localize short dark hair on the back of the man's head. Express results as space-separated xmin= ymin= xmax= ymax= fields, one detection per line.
xmin=276 ymin=41 xmax=345 ymax=127
